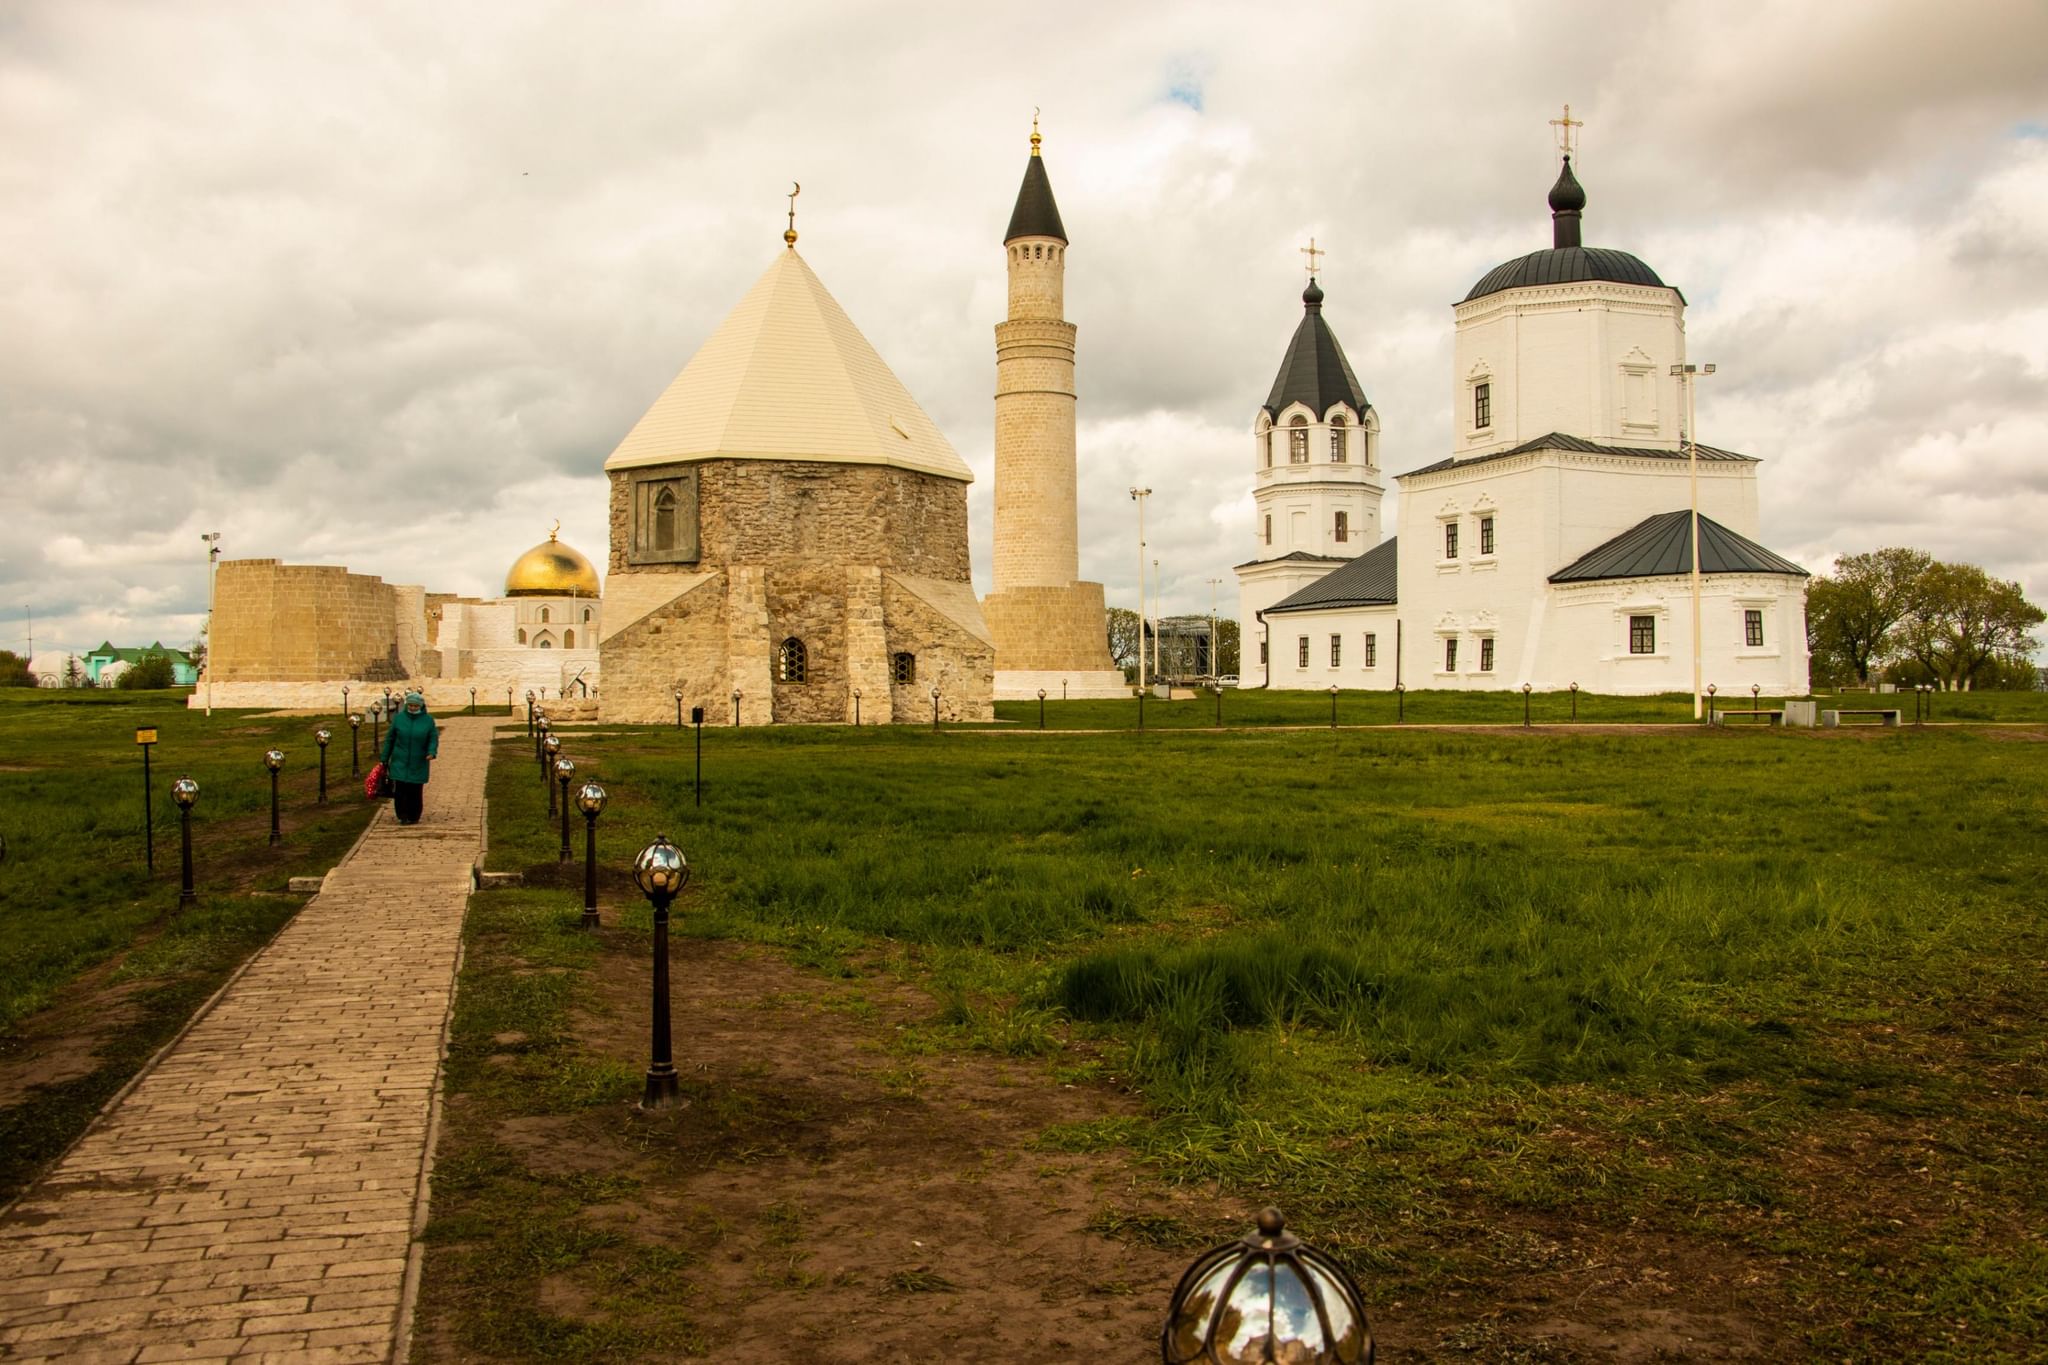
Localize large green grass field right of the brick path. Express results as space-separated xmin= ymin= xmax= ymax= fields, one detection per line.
xmin=451 ymin=720 xmax=2048 ymax=1361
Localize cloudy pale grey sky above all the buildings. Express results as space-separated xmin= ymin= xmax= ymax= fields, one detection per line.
xmin=0 ymin=0 xmax=2048 ymax=663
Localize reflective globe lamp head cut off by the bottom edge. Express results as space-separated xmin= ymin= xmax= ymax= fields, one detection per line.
xmin=1159 ymin=1209 xmax=1372 ymax=1365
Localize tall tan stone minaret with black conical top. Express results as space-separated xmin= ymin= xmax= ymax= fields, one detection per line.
xmin=983 ymin=119 xmax=1122 ymax=698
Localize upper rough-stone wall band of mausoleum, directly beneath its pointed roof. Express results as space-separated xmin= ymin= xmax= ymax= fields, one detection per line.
xmin=610 ymin=460 xmax=969 ymax=581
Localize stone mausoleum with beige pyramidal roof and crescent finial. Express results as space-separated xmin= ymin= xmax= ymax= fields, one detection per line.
xmin=598 ymin=225 xmax=995 ymax=724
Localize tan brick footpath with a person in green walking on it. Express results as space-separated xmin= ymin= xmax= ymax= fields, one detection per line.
xmin=0 ymin=718 xmax=492 ymax=1361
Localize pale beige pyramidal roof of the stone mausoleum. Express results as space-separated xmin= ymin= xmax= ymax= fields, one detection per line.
xmin=604 ymin=248 xmax=975 ymax=483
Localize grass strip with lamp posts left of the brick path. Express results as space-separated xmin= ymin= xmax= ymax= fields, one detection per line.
xmin=0 ymin=690 xmax=371 ymax=1201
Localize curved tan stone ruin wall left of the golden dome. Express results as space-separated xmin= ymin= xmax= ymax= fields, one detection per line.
xmin=211 ymin=559 xmax=426 ymax=686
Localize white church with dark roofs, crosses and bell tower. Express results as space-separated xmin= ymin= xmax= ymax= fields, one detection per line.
xmin=1237 ymin=151 xmax=1806 ymax=696
